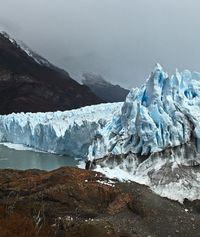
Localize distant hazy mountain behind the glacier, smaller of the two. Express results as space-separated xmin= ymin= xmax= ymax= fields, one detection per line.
xmin=82 ymin=73 xmax=129 ymax=102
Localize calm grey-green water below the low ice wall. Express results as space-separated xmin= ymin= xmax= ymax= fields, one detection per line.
xmin=0 ymin=145 xmax=78 ymax=170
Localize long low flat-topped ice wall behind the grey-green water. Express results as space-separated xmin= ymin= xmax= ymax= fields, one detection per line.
xmin=0 ymin=103 xmax=122 ymax=158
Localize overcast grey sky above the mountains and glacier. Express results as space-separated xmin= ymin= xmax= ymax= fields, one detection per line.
xmin=0 ymin=0 xmax=200 ymax=88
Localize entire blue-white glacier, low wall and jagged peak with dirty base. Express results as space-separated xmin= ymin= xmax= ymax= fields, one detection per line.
xmin=0 ymin=64 xmax=200 ymax=202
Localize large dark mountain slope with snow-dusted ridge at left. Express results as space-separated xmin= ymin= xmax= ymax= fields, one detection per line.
xmin=0 ymin=32 xmax=103 ymax=114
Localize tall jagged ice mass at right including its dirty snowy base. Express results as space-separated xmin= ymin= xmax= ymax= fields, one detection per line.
xmin=84 ymin=64 xmax=200 ymax=203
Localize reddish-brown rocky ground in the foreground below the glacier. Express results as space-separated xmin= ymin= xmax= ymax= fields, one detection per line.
xmin=0 ymin=168 xmax=200 ymax=237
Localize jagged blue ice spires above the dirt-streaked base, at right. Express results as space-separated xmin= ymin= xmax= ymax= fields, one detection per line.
xmin=89 ymin=64 xmax=200 ymax=159
